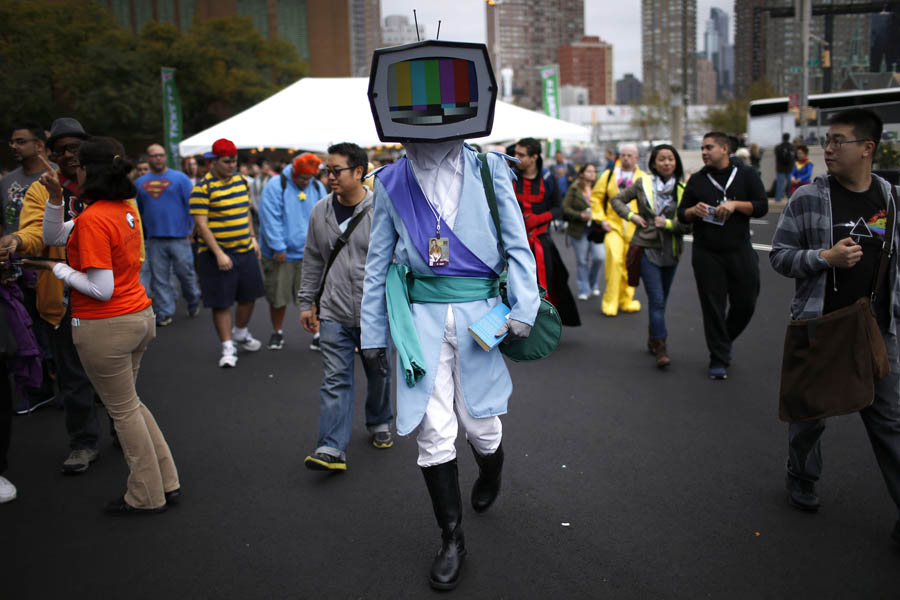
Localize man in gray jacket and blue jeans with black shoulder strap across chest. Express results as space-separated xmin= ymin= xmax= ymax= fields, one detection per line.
xmin=298 ymin=142 xmax=394 ymax=472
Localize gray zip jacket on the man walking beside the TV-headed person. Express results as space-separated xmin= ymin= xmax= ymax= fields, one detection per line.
xmin=298 ymin=188 xmax=373 ymax=327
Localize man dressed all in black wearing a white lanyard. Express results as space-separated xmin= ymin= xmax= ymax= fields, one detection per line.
xmin=678 ymin=131 xmax=769 ymax=379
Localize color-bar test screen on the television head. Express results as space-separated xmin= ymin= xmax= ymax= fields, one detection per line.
xmin=388 ymin=58 xmax=478 ymax=125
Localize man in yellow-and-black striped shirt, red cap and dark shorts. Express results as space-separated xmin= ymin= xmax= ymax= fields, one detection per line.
xmin=191 ymin=138 xmax=264 ymax=367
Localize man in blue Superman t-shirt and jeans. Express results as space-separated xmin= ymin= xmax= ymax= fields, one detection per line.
xmin=134 ymin=144 xmax=200 ymax=327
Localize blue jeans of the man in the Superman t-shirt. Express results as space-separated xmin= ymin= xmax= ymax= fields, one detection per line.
xmin=146 ymin=238 xmax=200 ymax=320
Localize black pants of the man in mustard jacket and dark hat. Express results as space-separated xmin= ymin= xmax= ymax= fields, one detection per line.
xmin=50 ymin=311 xmax=100 ymax=450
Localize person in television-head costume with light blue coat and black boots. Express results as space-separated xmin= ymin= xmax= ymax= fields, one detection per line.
xmin=361 ymin=41 xmax=540 ymax=589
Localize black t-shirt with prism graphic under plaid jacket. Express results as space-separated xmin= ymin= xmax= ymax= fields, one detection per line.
xmin=823 ymin=177 xmax=890 ymax=329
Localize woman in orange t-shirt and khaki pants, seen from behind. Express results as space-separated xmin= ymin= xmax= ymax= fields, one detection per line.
xmin=30 ymin=137 xmax=181 ymax=515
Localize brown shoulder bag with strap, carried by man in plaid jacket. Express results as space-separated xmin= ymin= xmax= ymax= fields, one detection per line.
xmin=778 ymin=188 xmax=897 ymax=423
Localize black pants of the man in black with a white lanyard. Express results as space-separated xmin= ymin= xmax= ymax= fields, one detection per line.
xmin=691 ymin=244 xmax=759 ymax=367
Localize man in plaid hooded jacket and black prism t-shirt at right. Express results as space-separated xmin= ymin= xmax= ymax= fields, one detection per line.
xmin=769 ymin=108 xmax=900 ymax=544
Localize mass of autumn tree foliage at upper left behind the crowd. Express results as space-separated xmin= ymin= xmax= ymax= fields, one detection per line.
xmin=0 ymin=0 xmax=308 ymax=163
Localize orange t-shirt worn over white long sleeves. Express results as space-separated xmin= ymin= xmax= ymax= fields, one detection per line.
xmin=66 ymin=200 xmax=151 ymax=319
